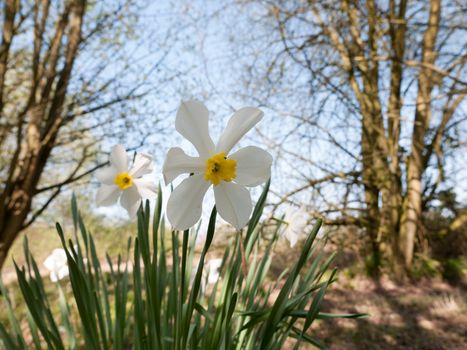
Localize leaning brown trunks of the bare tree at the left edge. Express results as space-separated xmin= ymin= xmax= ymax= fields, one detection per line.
xmin=0 ymin=0 xmax=86 ymax=270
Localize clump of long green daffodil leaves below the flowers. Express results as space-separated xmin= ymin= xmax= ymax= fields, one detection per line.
xmin=0 ymin=185 xmax=363 ymax=350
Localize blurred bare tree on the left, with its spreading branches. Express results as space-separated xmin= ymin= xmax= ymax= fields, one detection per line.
xmin=0 ymin=0 xmax=175 ymax=268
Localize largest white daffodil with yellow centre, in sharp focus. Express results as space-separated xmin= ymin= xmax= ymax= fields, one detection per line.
xmin=162 ymin=101 xmax=272 ymax=230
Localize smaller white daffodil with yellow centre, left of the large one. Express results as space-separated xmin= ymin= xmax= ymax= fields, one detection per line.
xmin=96 ymin=145 xmax=157 ymax=218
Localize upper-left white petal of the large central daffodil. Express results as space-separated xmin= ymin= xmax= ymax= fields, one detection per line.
xmin=175 ymin=101 xmax=214 ymax=157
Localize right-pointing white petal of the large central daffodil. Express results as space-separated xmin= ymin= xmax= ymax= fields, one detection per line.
xmin=229 ymin=146 xmax=272 ymax=186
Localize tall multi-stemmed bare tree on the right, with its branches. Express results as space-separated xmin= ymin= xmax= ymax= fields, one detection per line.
xmin=222 ymin=0 xmax=467 ymax=278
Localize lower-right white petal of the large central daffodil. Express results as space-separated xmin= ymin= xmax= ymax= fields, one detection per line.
xmin=214 ymin=182 xmax=252 ymax=230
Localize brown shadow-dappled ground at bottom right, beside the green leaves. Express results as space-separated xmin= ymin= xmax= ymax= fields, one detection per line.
xmin=314 ymin=277 xmax=467 ymax=350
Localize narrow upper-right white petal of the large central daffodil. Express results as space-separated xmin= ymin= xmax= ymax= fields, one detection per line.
xmin=216 ymin=107 xmax=263 ymax=154
